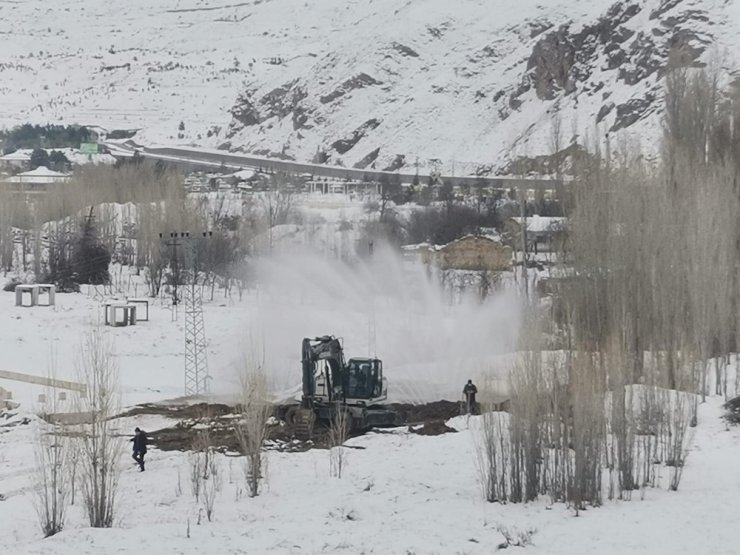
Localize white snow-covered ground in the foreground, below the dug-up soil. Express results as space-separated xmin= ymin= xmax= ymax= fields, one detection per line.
xmin=0 ymin=397 xmax=740 ymax=555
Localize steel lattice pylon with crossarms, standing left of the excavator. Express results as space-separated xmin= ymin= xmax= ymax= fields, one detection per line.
xmin=160 ymin=231 xmax=212 ymax=395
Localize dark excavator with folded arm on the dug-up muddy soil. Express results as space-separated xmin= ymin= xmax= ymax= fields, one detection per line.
xmin=285 ymin=335 xmax=401 ymax=440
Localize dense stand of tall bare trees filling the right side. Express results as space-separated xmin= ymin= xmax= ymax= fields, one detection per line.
xmin=478 ymin=64 xmax=740 ymax=511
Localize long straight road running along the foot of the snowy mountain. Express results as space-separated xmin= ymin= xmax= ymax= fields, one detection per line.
xmin=103 ymin=141 xmax=559 ymax=190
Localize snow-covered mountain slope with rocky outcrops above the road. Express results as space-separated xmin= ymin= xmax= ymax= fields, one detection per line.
xmin=0 ymin=0 xmax=740 ymax=174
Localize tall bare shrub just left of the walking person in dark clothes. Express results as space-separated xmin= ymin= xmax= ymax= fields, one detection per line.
xmin=77 ymin=327 xmax=123 ymax=528
